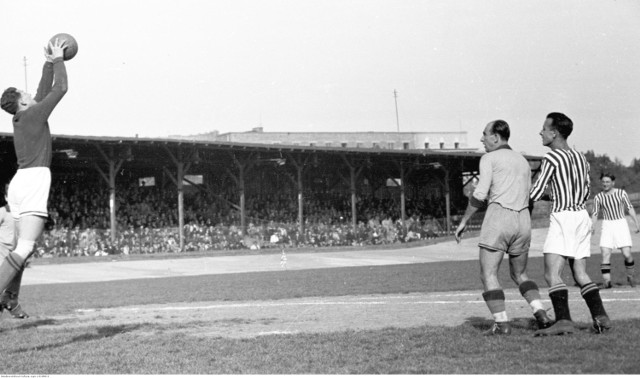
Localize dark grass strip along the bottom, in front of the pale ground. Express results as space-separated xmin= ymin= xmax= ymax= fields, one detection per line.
xmin=0 ymin=320 xmax=640 ymax=374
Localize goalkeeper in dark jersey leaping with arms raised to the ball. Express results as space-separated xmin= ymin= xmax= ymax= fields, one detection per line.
xmin=0 ymin=39 xmax=67 ymax=292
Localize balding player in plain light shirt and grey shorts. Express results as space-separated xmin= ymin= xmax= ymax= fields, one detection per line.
xmin=456 ymin=120 xmax=552 ymax=336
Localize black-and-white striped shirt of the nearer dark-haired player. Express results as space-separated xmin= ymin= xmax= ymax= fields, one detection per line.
xmin=530 ymin=148 xmax=591 ymax=213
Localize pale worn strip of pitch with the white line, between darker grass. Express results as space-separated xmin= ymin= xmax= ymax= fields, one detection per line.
xmin=15 ymin=287 xmax=640 ymax=338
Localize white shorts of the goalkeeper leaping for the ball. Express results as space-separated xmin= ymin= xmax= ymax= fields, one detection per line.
xmin=7 ymin=167 xmax=51 ymax=219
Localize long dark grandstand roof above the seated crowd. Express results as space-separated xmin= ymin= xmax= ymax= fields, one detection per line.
xmin=0 ymin=133 xmax=541 ymax=181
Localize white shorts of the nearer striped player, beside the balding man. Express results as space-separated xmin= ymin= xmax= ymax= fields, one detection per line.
xmin=542 ymin=210 xmax=591 ymax=259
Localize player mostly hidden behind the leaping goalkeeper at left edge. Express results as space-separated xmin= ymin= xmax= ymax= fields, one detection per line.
xmin=0 ymin=184 xmax=29 ymax=319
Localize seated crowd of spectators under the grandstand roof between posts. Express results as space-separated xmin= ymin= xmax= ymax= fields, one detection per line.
xmin=21 ymin=173 xmax=464 ymax=257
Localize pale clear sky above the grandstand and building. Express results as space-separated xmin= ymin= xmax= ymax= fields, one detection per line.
xmin=0 ymin=0 xmax=640 ymax=165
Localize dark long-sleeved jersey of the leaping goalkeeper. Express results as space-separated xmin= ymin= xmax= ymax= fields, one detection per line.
xmin=13 ymin=58 xmax=67 ymax=169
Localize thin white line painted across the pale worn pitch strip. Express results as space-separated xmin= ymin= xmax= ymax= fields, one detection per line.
xmin=76 ymin=298 xmax=640 ymax=313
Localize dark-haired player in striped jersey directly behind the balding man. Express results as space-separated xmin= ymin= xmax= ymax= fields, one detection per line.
xmin=530 ymin=113 xmax=611 ymax=336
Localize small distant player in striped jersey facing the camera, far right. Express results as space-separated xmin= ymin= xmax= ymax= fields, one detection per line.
xmin=591 ymin=173 xmax=640 ymax=289
